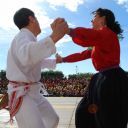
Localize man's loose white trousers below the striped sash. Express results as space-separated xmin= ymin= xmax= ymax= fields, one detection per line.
xmin=15 ymin=84 xmax=59 ymax=128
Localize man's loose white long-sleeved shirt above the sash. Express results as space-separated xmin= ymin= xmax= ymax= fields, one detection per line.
xmin=6 ymin=28 xmax=56 ymax=83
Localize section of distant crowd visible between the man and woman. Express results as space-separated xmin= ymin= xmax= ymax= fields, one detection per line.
xmin=41 ymin=77 xmax=90 ymax=97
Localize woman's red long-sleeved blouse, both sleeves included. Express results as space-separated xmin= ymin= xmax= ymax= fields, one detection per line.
xmin=63 ymin=27 xmax=120 ymax=71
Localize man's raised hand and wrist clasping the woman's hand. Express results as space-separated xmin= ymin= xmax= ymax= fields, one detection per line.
xmin=51 ymin=18 xmax=69 ymax=43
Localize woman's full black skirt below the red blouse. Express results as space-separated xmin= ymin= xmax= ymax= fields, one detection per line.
xmin=75 ymin=68 xmax=128 ymax=128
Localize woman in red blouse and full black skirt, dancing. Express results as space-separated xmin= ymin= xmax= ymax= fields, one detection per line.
xmin=57 ymin=8 xmax=128 ymax=128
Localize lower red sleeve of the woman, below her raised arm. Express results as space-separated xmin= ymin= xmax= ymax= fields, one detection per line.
xmin=63 ymin=50 xmax=92 ymax=62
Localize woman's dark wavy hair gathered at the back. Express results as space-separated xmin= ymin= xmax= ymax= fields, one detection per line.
xmin=92 ymin=8 xmax=123 ymax=38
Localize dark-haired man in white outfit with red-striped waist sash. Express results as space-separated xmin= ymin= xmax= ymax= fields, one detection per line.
xmin=6 ymin=8 xmax=68 ymax=128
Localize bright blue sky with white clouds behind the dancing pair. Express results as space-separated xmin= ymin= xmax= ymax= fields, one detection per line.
xmin=0 ymin=0 xmax=128 ymax=75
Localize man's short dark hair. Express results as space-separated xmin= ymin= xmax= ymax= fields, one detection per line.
xmin=13 ymin=8 xmax=35 ymax=29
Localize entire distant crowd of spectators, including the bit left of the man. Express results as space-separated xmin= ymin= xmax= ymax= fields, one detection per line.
xmin=0 ymin=72 xmax=128 ymax=97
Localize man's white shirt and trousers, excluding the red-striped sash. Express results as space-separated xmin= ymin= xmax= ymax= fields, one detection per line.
xmin=6 ymin=28 xmax=59 ymax=128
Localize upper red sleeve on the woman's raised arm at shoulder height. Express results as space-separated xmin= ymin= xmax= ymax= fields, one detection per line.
xmin=69 ymin=27 xmax=107 ymax=47
